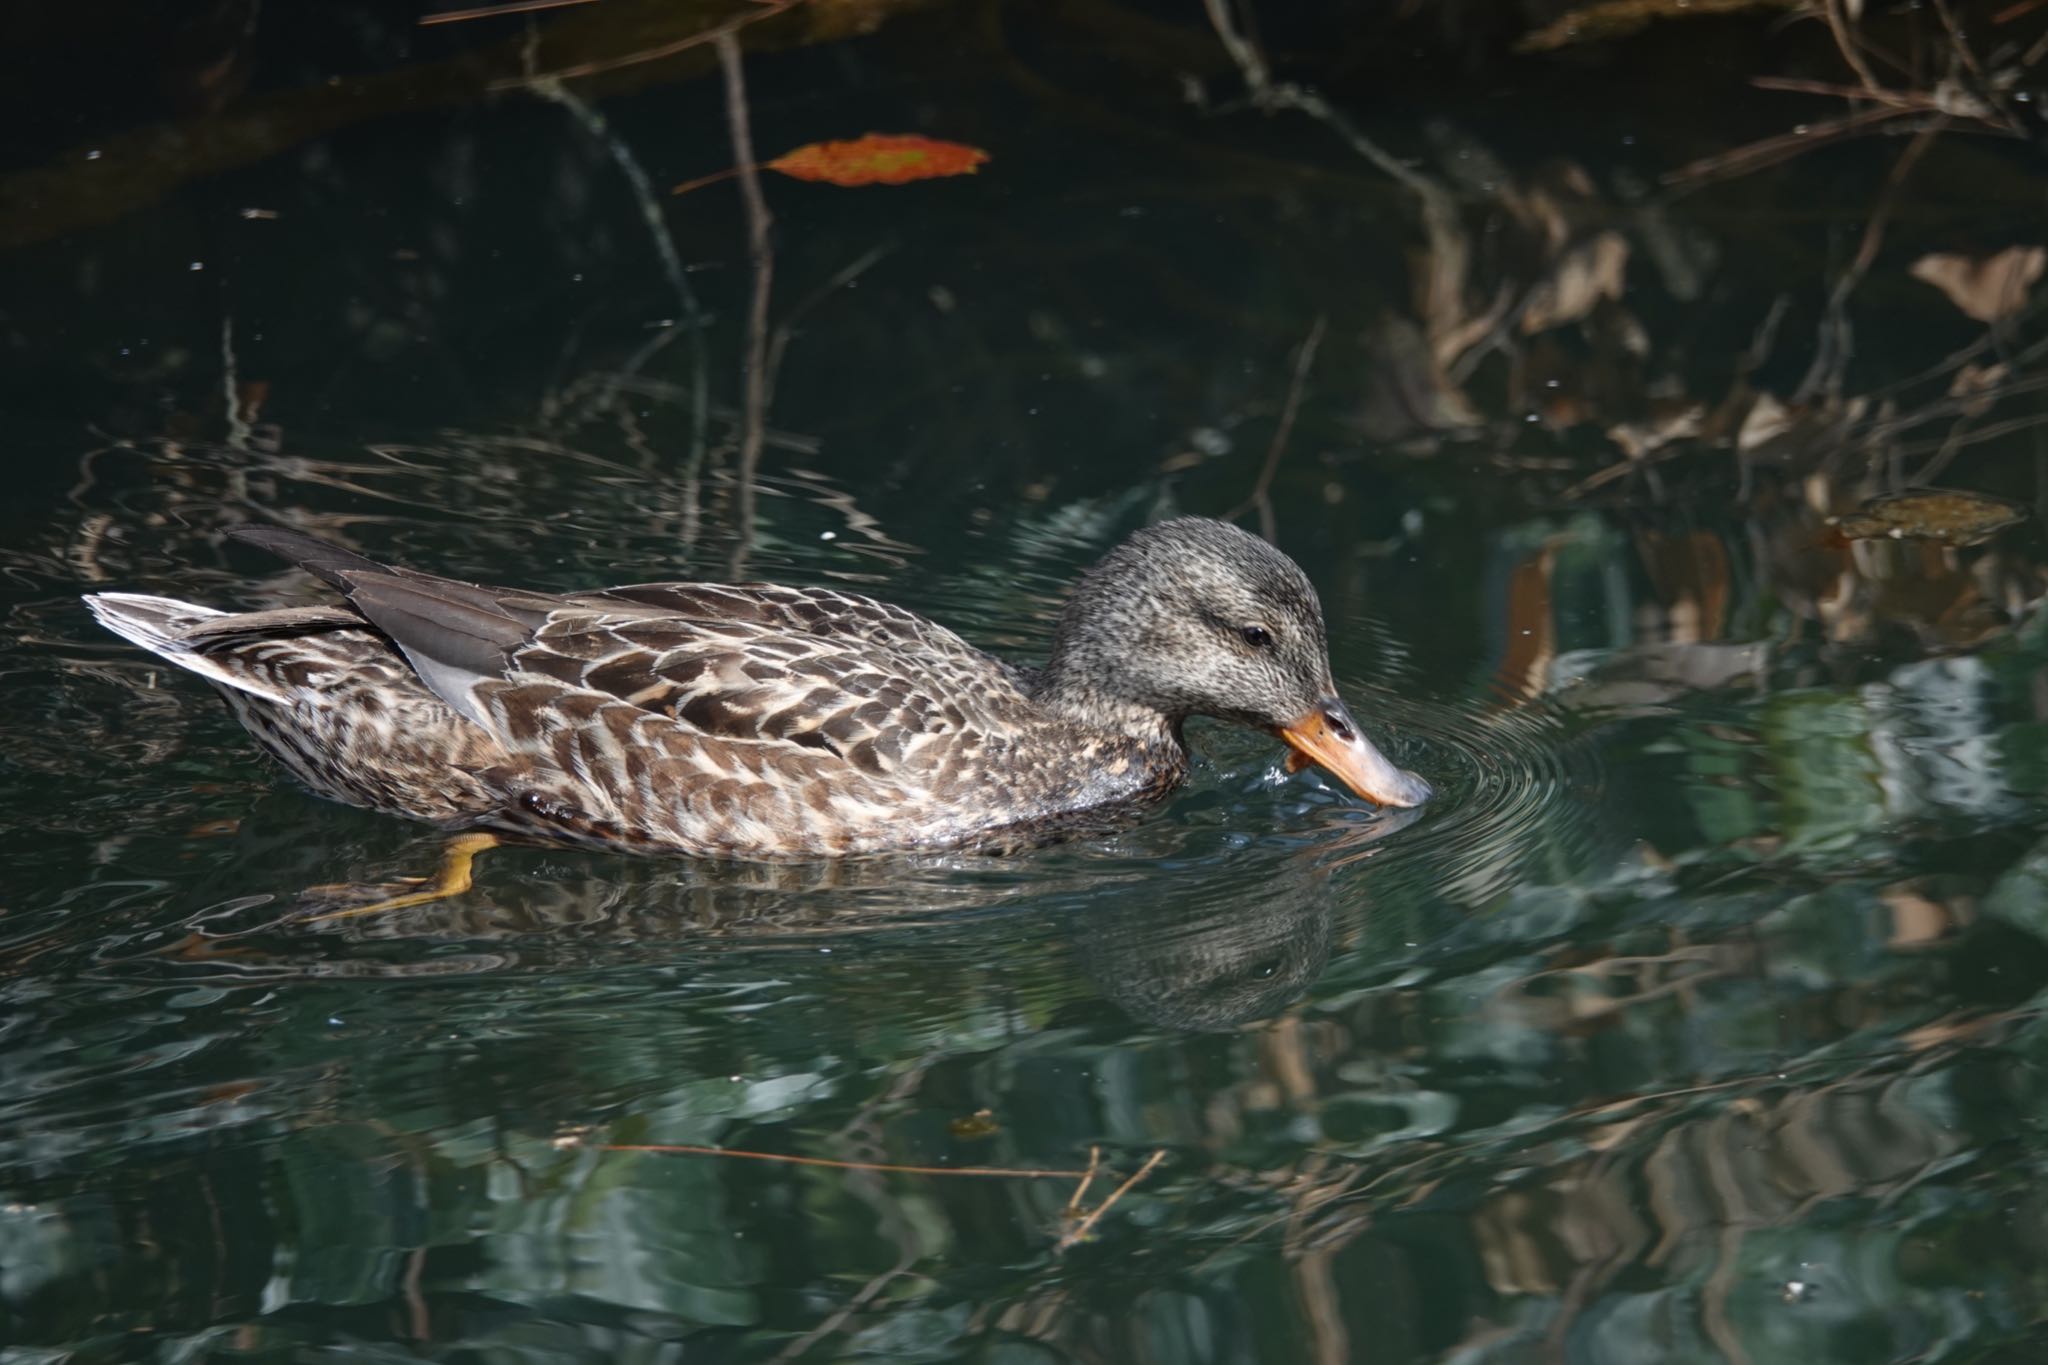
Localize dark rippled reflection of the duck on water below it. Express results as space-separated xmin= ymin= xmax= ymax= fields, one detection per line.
xmin=94 ymin=812 xmax=1417 ymax=1031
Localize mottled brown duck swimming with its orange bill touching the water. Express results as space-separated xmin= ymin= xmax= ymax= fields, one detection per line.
xmin=84 ymin=516 xmax=1432 ymax=862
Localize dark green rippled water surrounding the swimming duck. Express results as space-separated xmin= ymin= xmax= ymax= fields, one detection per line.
xmin=0 ymin=6 xmax=2048 ymax=1365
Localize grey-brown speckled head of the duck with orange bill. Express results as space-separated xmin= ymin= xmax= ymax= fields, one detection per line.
xmin=1042 ymin=516 xmax=1430 ymax=806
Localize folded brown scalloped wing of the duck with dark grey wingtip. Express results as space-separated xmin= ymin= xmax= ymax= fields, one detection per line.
xmin=244 ymin=530 xmax=1028 ymax=778
